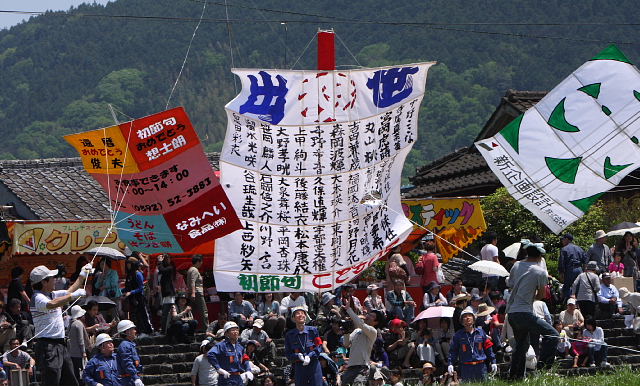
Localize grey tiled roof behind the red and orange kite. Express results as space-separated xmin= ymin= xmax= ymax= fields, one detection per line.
xmin=0 ymin=153 xmax=219 ymax=220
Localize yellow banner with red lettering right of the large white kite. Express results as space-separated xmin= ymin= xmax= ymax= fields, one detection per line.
xmin=402 ymin=198 xmax=487 ymax=262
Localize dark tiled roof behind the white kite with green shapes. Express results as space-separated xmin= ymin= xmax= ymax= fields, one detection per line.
xmin=403 ymin=90 xmax=546 ymax=198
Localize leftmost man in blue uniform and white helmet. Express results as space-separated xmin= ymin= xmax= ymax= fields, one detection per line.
xmin=82 ymin=333 xmax=122 ymax=386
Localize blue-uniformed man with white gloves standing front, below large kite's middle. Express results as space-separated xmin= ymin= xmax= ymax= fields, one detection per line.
xmin=284 ymin=307 xmax=323 ymax=386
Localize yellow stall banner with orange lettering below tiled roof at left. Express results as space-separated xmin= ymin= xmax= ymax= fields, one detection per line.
xmin=13 ymin=221 xmax=125 ymax=255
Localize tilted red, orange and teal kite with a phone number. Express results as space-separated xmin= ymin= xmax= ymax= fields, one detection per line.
xmin=65 ymin=107 xmax=241 ymax=253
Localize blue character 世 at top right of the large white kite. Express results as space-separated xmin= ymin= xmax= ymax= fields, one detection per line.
xmin=367 ymin=67 xmax=418 ymax=107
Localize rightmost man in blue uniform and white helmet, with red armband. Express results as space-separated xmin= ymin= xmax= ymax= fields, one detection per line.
xmin=447 ymin=307 xmax=498 ymax=382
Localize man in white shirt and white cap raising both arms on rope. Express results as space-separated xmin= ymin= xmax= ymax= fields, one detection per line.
xmin=29 ymin=264 xmax=93 ymax=386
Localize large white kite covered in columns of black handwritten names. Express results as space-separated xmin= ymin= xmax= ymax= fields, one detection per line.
xmin=214 ymin=63 xmax=433 ymax=292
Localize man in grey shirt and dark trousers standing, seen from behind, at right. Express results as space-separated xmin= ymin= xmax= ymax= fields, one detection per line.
xmin=507 ymin=239 xmax=559 ymax=380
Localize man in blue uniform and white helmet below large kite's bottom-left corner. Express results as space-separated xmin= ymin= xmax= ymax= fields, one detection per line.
xmin=207 ymin=322 xmax=253 ymax=386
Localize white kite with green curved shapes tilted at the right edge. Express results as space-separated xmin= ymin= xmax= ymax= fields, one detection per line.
xmin=476 ymin=45 xmax=640 ymax=234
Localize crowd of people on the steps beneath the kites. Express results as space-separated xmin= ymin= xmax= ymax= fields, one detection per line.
xmin=0 ymin=231 xmax=640 ymax=386
